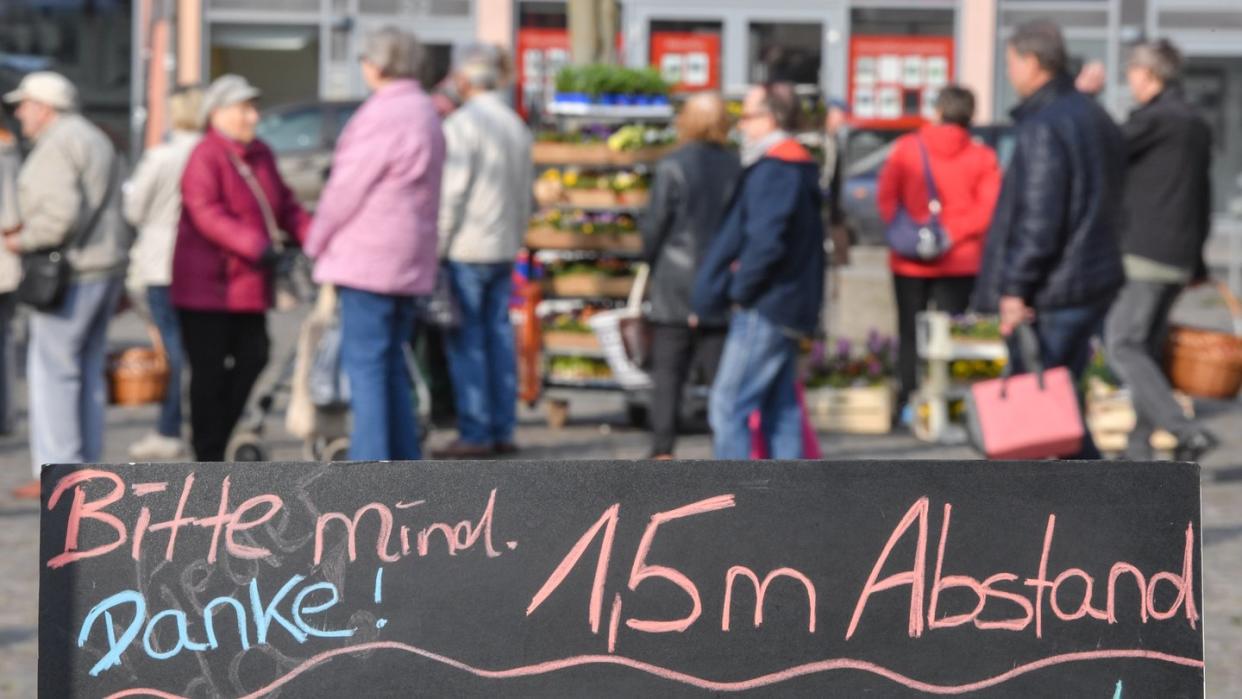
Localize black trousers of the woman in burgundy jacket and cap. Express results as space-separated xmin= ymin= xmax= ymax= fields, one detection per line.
xmin=179 ymin=310 xmax=270 ymax=461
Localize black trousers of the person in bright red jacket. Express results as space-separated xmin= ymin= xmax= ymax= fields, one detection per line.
xmin=893 ymin=274 xmax=975 ymax=406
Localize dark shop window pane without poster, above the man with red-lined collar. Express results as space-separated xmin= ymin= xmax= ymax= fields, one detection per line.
xmin=748 ymin=22 xmax=823 ymax=84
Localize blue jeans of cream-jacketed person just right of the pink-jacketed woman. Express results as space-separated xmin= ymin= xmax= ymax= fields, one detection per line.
xmin=447 ymin=262 xmax=518 ymax=447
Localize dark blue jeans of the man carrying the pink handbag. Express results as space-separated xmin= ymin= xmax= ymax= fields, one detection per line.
xmin=1010 ymin=297 xmax=1113 ymax=459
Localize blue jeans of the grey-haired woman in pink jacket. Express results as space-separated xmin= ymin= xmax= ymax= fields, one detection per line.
xmin=338 ymin=287 xmax=422 ymax=461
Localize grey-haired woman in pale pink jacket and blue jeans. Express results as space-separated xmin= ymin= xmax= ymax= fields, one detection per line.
xmin=306 ymin=29 xmax=445 ymax=461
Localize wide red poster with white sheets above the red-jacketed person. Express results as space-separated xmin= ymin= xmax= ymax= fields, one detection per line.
xmin=850 ymin=36 xmax=955 ymax=129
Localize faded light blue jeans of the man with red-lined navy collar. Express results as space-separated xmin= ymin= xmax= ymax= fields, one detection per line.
xmin=708 ymin=310 xmax=802 ymax=459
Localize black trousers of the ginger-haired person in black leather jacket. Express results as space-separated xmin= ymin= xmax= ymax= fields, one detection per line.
xmin=650 ymin=323 xmax=728 ymax=456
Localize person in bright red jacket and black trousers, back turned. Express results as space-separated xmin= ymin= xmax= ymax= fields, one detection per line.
xmin=876 ymin=86 xmax=1001 ymax=414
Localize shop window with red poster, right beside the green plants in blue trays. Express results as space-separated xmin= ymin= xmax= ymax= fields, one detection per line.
xmin=647 ymin=20 xmax=722 ymax=92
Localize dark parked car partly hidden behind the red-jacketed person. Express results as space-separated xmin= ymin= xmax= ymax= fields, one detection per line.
xmin=841 ymin=125 xmax=1013 ymax=245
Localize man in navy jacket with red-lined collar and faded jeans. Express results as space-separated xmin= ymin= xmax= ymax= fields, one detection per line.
xmin=693 ymin=83 xmax=823 ymax=459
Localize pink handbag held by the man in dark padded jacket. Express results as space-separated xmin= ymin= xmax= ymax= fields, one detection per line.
xmin=966 ymin=325 xmax=1086 ymax=459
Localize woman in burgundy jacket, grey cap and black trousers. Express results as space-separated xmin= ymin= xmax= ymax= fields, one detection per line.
xmin=171 ymin=76 xmax=311 ymax=461
